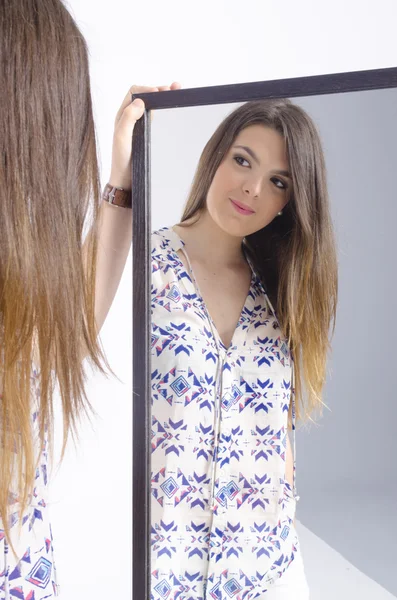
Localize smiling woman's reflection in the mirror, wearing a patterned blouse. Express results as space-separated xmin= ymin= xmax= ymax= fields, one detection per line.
xmin=151 ymin=100 xmax=337 ymax=600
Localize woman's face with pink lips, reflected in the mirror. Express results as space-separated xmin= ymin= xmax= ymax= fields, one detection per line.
xmin=206 ymin=125 xmax=292 ymax=237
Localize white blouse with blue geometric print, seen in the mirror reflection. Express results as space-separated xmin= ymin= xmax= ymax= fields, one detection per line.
xmin=151 ymin=227 xmax=299 ymax=600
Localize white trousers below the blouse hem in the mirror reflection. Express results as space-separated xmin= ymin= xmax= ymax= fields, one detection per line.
xmin=255 ymin=546 xmax=309 ymax=600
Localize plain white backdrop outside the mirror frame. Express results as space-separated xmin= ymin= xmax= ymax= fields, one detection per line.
xmin=51 ymin=0 xmax=397 ymax=600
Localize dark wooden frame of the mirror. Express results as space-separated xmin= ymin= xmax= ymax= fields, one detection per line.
xmin=132 ymin=67 xmax=397 ymax=600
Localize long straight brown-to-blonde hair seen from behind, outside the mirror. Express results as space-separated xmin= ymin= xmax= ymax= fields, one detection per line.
xmin=0 ymin=0 xmax=114 ymax=549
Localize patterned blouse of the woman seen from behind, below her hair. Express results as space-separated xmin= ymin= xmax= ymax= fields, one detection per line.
xmin=0 ymin=365 xmax=60 ymax=600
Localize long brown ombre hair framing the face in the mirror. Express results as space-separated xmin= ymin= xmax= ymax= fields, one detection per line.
xmin=180 ymin=99 xmax=338 ymax=422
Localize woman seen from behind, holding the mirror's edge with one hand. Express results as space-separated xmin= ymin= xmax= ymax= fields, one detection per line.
xmin=0 ymin=0 xmax=179 ymax=600
